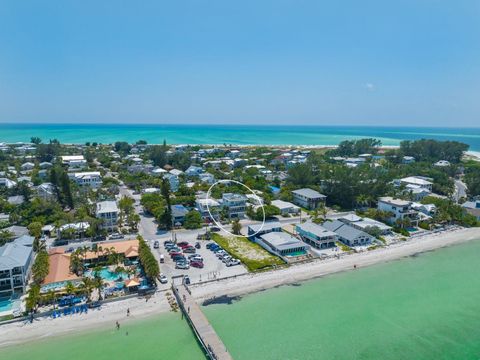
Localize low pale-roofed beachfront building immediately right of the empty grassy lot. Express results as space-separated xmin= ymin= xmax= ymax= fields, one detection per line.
xmin=257 ymin=231 xmax=310 ymax=256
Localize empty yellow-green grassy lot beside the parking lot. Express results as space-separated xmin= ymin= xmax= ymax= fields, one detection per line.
xmin=212 ymin=234 xmax=285 ymax=271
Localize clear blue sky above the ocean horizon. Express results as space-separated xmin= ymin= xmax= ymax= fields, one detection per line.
xmin=0 ymin=0 xmax=480 ymax=127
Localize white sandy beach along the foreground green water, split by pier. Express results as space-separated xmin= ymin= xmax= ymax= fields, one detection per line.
xmin=0 ymin=228 xmax=480 ymax=347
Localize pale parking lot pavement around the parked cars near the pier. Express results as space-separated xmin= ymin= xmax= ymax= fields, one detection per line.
xmin=150 ymin=233 xmax=248 ymax=289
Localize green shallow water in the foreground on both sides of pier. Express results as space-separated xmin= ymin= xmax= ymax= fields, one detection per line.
xmin=0 ymin=240 xmax=480 ymax=360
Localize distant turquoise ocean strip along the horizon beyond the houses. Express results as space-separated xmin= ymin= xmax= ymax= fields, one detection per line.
xmin=0 ymin=124 xmax=480 ymax=151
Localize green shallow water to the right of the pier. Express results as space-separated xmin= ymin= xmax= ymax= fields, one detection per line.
xmin=203 ymin=241 xmax=480 ymax=360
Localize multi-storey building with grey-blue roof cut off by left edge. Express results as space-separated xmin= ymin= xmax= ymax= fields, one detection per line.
xmin=0 ymin=235 xmax=34 ymax=298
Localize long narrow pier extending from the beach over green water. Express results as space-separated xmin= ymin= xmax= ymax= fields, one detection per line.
xmin=173 ymin=284 xmax=233 ymax=360
